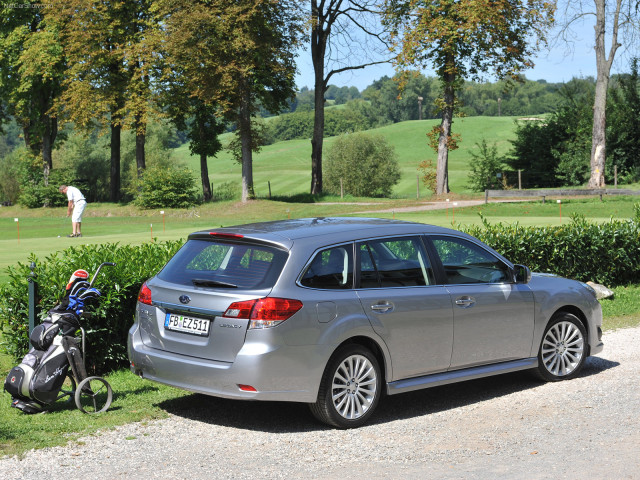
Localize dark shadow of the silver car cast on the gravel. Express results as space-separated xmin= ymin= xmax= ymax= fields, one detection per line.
xmin=158 ymin=357 xmax=619 ymax=433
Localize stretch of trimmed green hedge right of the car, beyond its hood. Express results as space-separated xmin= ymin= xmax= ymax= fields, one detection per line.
xmin=464 ymin=214 xmax=640 ymax=286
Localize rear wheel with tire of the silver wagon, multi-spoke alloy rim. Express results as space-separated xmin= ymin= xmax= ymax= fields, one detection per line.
xmin=309 ymin=345 xmax=382 ymax=428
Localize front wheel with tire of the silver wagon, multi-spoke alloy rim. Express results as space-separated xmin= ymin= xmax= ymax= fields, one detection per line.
xmin=536 ymin=312 xmax=587 ymax=382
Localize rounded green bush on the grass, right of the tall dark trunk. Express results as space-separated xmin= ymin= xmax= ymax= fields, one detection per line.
xmin=323 ymin=133 xmax=400 ymax=197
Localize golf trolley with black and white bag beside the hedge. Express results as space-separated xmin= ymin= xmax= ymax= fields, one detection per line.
xmin=4 ymin=262 xmax=115 ymax=413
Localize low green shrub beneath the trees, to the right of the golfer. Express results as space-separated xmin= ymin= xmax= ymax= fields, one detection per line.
xmin=133 ymin=165 xmax=198 ymax=208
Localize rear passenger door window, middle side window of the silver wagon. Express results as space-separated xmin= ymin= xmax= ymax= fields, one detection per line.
xmin=360 ymin=237 xmax=433 ymax=288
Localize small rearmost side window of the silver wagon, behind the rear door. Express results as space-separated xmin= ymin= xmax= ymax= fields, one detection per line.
xmin=300 ymin=245 xmax=353 ymax=290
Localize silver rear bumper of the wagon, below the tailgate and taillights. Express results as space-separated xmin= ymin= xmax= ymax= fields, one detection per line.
xmin=128 ymin=323 xmax=331 ymax=403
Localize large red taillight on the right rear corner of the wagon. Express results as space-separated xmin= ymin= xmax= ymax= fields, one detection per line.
xmin=223 ymin=297 xmax=302 ymax=328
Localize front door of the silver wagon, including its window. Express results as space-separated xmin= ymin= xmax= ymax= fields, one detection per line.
xmin=428 ymin=235 xmax=534 ymax=369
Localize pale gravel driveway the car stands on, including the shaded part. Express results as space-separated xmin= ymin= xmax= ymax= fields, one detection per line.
xmin=0 ymin=328 xmax=640 ymax=480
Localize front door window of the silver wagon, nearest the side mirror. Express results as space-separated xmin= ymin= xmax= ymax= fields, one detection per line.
xmin=432 ymin=237 xmax=512 ymax=284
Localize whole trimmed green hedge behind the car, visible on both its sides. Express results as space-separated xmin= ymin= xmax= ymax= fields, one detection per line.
xmin=0 ymin=214 xmax=640 ymax=373
